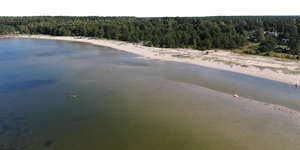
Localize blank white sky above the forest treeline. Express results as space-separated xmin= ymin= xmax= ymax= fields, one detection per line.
xmin=0 ymin=0 xmax=300 ymax=17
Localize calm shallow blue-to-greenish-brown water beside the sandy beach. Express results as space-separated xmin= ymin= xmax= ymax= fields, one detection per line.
xmin=0 ymin=39 xmax=300 ymax=150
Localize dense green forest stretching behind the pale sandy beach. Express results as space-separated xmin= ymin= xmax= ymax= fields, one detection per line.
xmin=0 ymin=16 xmax=300 ymax=59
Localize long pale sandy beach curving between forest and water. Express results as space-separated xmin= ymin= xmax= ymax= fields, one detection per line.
xmin=5 ymin=35 xmax=300 ymax=85
